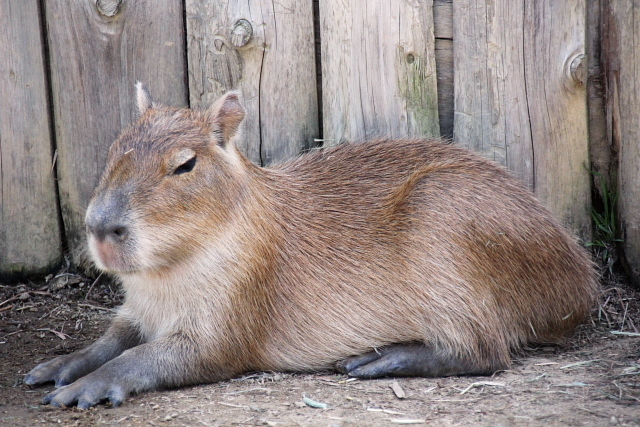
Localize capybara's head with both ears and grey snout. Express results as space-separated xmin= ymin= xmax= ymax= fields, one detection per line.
xmin=85 ymin=83 xmax=249 ymax=274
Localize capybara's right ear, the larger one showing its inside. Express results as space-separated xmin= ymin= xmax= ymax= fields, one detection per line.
xmin=208 ymin=91 xmax=245 ymax=148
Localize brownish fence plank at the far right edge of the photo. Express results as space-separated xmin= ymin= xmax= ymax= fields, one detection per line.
xmin=603 ymin=0 xmax=640 ymax=286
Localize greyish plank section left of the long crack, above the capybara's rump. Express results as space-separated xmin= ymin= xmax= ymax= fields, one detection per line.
xmin=453 ymin=0 xmax=535 ymax=188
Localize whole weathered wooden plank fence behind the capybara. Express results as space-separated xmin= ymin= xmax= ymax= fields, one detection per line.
xmin=0 ymin=0 xmax=640 ymax=288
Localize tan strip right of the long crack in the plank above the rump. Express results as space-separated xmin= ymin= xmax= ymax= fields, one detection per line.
xmin=524 ymin=0 xmax=591 ymax=241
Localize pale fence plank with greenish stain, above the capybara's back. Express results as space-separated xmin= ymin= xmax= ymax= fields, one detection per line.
xmin=320 ymin=0 xmax=440 ymax=145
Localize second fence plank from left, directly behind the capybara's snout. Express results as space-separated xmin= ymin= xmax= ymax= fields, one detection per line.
xmin=44 ymin=0 xmax=187 ymax=263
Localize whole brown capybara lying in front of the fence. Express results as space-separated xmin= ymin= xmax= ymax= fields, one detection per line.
xmin=24 ymin=84 xmax=597 ymax=408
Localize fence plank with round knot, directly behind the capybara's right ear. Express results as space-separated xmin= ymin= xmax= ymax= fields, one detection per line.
xmin=186 ymin=0 xmax=319 ymax=164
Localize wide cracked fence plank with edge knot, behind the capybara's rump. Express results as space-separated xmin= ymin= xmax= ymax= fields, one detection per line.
xmin=454 ymin=0 xmax=591 ymax=239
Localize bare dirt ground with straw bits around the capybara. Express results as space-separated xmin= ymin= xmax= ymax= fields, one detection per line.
xmin=0 ymin=273 xmax=640 ymax=426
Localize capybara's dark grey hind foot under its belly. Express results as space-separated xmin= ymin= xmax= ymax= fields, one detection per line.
xmin=336 ymin=343 xmax=495 ymax=378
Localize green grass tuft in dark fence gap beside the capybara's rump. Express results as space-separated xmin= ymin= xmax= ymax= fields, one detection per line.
xmin=587 ymin=170 xmax=622 ymax=274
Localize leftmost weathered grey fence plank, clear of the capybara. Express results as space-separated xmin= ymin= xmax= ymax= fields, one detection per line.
xmin=0 ymin=0 xmax=62 ymax=276
